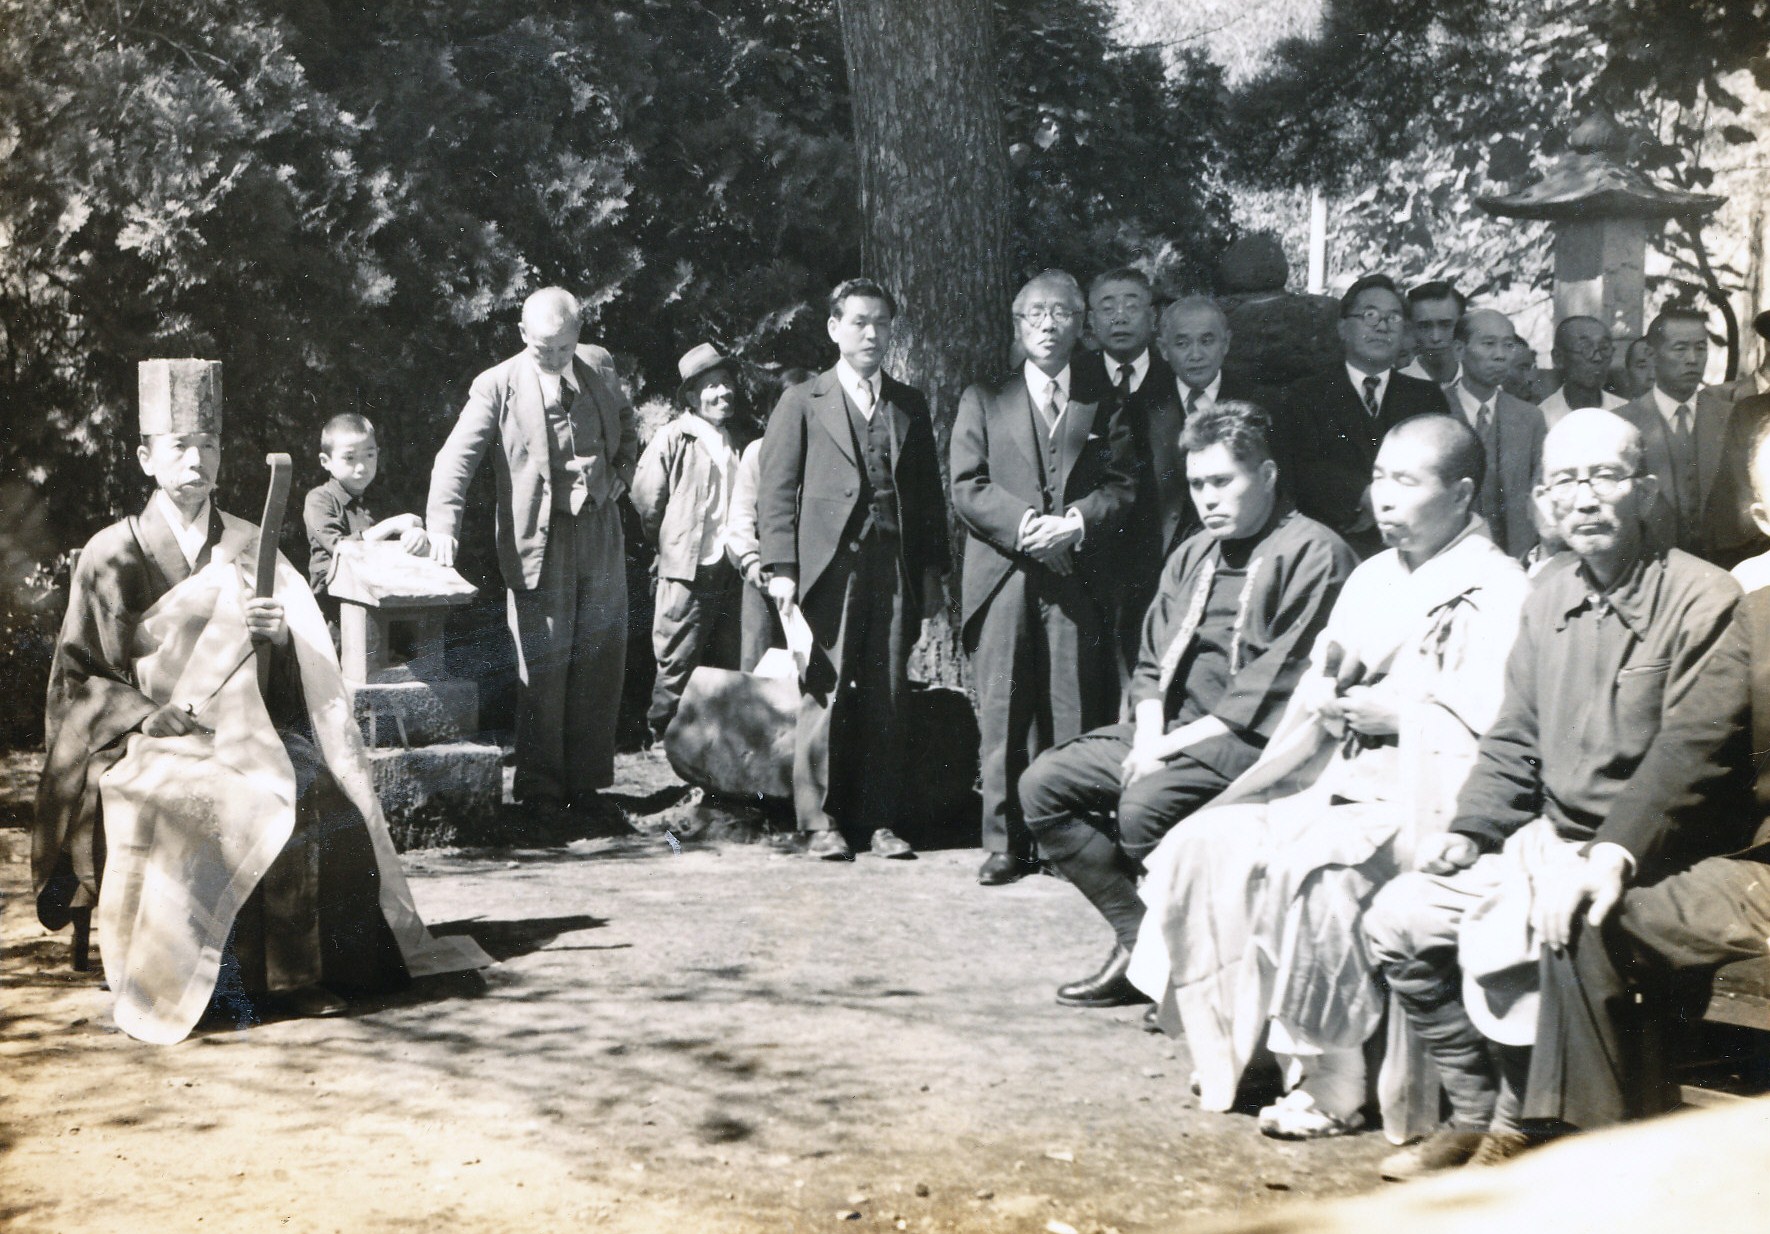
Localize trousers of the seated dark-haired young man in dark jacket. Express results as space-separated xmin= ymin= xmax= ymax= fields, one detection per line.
xmin=1020 ymin=724 xmax=1258 ymax=949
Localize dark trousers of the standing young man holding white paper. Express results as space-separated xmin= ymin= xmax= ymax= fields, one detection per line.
xmin=793 ymin=531 xmax=917 ymax=846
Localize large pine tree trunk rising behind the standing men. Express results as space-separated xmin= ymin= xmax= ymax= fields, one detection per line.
xmin=839 ymin=0 xmax=1009 ymax=685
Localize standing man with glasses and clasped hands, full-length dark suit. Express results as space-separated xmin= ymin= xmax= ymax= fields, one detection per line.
xmin=950 ymin=271 xmax=1136 ymax=887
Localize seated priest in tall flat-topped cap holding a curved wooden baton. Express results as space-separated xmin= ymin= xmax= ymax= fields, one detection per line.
xmin=32 ymin=361 xmax=490 ymax=1043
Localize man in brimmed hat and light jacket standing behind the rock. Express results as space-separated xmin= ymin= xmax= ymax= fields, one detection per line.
xmin=634 ymin=343 xmax=750 ymax=740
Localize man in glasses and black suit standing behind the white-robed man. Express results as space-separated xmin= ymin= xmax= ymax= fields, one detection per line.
xmin=1274 ymin=274 xmax=1450 ymax=558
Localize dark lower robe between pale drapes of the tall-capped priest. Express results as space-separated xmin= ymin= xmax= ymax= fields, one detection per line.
xmin=218 ymin=733 xmax=405 ymax=1000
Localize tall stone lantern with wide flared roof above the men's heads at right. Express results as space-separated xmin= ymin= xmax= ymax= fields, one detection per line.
xmin=1476 ymin=112 xmax=1728 ymax=336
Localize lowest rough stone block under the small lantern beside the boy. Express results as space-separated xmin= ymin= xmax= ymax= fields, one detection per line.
xmin=368 ymin=742 xmax=503 ymax=850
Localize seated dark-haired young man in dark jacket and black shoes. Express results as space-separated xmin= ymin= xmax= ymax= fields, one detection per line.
xmin=1020 ymin=400 xmax=1358 ymax=1007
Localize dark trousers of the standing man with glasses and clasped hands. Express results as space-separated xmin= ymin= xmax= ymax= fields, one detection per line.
xmin=972 ymin=568 xmax=1119 ymax=859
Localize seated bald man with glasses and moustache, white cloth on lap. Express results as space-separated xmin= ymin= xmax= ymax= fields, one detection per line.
xmin=1365 ymin=407 xmax=1740 ymax=1177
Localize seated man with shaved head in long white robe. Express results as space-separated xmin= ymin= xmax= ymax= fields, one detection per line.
xmin=1129 ymin=416 xmax=1528 ymax=1138
